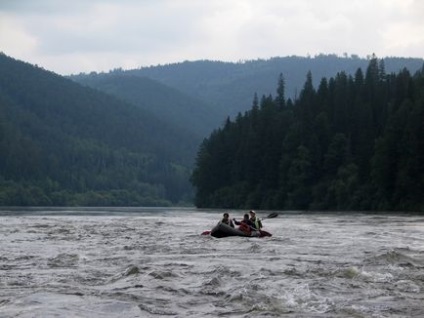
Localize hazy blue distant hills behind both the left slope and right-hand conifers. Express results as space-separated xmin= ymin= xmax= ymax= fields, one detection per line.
xmin=70 ymin=55 xmax=424 ymax=137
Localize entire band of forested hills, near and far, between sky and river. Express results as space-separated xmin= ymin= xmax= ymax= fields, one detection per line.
xmin=0 ymin=54 xmax=424 ymax=211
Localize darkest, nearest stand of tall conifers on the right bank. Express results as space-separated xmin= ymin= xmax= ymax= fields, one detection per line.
xmin=191 ymin=57 xmax=424 ymax=212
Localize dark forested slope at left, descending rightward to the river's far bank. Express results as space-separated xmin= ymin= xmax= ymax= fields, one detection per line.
xmin=0 ymin=54 xmax=201 ymax=206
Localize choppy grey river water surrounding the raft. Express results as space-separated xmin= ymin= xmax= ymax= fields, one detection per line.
xmin=0 ymin=209 xmax=424 ymax=318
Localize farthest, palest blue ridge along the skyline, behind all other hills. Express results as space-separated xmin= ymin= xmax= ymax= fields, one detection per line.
xmin=116 ymin=54 xmax=424 ymax=119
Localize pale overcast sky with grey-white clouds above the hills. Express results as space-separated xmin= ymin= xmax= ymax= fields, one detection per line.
xmin=0 ymin=0 xmax=424 ymax=75
